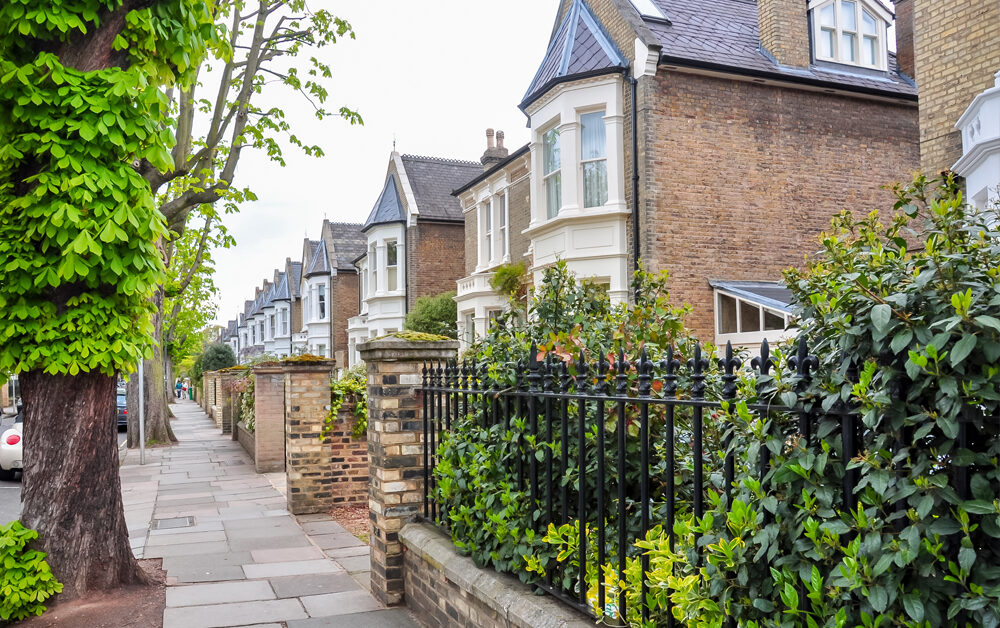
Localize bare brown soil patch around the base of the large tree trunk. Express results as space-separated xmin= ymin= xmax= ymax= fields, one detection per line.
xmin=16 ymin=558 xmax=167 ymax=628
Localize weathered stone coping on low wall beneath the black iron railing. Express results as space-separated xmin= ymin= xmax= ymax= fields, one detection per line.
xmin=399 ymin=523 xmax=594 ymax=628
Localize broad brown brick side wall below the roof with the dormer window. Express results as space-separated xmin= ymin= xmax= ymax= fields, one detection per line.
xmin=640 ymin=70 xmax=918 ymax=339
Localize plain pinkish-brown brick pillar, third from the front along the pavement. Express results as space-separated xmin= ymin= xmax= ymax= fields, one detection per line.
xmin=253 ymin=365 xmax=285 ymax=473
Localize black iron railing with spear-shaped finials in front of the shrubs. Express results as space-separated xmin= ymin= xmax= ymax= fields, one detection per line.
xmin=422 ymin=341 xmax=860 ymax=618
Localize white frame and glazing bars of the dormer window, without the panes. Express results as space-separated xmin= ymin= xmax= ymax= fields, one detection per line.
xmin=809 ymin=0 xmax=892 ymax=71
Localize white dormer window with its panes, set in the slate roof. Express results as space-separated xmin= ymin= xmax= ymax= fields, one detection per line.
xmin=809 ymin=0 xmax=890 ymax=70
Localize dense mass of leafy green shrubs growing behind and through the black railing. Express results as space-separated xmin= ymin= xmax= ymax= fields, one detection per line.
xmin=437 ymin=177 xmax=1000 ymax=628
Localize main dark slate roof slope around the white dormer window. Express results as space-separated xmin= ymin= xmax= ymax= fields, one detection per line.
xmin=640 ymin=0 xmax=917 ymax=99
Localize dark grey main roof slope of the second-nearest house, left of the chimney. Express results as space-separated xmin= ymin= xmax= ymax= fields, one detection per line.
xmin=400 ymin=155 xmax=483 ymax=221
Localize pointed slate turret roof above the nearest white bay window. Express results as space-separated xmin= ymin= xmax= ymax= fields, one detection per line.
xmin=521 ymin=0 xmax=628 ymax=109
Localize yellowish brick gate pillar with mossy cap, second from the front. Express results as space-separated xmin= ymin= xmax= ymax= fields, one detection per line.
xmin=283 ymin=360 xmax=337 ymax=515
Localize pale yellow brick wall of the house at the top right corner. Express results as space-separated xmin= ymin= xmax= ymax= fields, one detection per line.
xmin=913 ymin=0 xmax=1000 ymax=173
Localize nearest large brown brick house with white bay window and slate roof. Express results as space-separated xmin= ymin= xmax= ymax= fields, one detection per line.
xmin=461 ymin=0 xmax=919 ymax=344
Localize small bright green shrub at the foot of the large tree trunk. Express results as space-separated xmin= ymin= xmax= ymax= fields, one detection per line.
xmin=0 ymin=520 xmax=63 ymax=622
